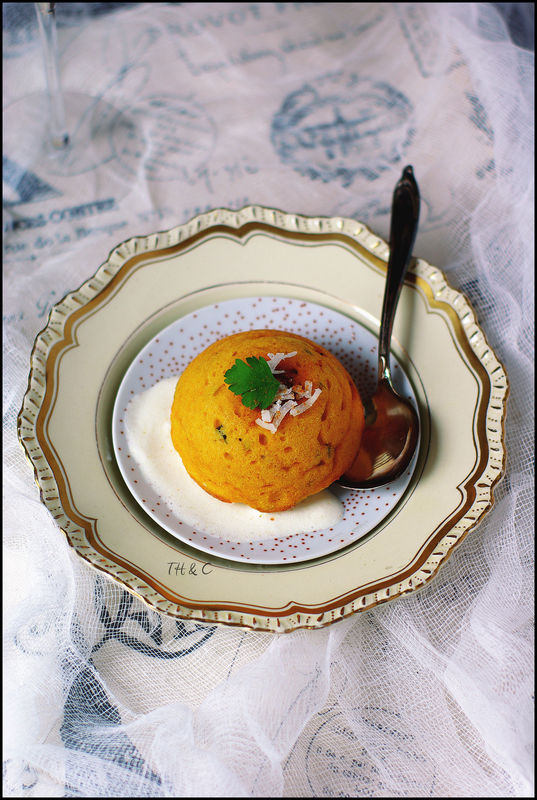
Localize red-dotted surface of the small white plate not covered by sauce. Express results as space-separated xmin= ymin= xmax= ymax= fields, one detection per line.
xmin=112 ymin=297 xmax=414 ymax=563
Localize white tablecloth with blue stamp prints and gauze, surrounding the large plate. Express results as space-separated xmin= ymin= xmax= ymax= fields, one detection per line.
xmin=3 ymin=3 xmax=534 ymax=797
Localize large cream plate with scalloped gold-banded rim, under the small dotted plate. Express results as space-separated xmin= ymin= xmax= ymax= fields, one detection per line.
xmin=18 ymin=206 xmax=508 ymax=631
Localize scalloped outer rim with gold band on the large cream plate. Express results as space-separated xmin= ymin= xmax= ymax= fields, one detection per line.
xmin=17 ymin=206 xmax=509 ymax=632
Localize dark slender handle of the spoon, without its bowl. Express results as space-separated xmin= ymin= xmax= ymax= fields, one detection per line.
xmin=379 ymin=166 xmax=420 ymax=382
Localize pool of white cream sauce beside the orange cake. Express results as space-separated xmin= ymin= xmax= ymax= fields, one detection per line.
xmin=125 ymin=378 xmax=343 ymax=541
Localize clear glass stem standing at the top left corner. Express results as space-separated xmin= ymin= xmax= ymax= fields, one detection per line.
xmin=35 ymin=3 xmax=69 ymax=150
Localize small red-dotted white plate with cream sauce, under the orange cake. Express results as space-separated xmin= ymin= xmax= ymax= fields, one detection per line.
xmin=112 ymin=295 xmax=418 ymax=564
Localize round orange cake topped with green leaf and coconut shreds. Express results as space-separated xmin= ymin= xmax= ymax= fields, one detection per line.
xmin=171 ymin=330 xmax=364 ymax=511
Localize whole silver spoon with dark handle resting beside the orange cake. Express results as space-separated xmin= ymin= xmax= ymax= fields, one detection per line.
xmin=337 ymin=166 xmax=420 ymax=489
